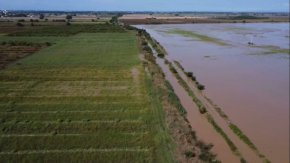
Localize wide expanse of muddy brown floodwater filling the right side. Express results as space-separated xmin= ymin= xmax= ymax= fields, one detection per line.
xmin=139 ymin=23 xmax=289 ymax=163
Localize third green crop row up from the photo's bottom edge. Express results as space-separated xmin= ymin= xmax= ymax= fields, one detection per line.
xmin=0 ymin=119 xmax=149 ymax=135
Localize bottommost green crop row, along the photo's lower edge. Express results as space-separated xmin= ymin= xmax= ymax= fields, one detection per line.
xmin=0 ymin=149 xmax=153 ymax=163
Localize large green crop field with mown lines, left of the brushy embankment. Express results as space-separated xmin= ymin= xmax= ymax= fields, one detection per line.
xmin=0 ymin=27 xmax=173 ymax=162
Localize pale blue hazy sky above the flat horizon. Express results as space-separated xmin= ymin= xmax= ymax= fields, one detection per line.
xmin=0 ymin=0 xmax=289 ymax=12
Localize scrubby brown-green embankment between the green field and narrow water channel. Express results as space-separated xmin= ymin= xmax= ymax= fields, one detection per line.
xmin=137 ymin=28 xmax=220 ymax=163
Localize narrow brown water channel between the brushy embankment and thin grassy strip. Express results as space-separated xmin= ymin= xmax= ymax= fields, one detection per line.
xmin=153 ymin=45 xmax=239 ymax=163
